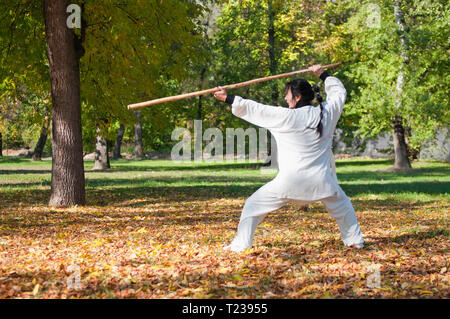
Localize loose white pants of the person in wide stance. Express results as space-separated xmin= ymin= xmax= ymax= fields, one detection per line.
xmin=225 ymin=184 xmax=364 ymax=252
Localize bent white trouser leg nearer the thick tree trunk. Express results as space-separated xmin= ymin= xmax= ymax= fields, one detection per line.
xmin=224 ymin=182 xmax=289 ymax=252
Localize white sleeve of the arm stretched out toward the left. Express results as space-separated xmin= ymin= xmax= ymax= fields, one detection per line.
xmin=231 ymin=96 xmax=295 ymax=130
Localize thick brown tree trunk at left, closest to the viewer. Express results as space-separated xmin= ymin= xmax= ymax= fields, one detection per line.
xmin=44 ymin=0 xmax=86 ymax=207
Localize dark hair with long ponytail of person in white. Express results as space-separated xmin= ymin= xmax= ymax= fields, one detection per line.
xmin=285 ymin=79 xmax=323 ymax=137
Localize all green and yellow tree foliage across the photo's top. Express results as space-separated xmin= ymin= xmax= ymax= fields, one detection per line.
xmin=0 ymin=0 xmax=450 ymax=164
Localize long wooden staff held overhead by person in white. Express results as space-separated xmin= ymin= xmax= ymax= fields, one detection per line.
xmin=128 ymin=62 xmax=342 ymax=110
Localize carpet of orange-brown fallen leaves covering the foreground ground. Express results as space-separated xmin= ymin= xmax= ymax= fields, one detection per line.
xmin=0 ymin=161 xmax=450 ymax=298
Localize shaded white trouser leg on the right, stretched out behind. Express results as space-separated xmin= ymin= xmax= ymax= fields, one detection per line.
xmin=322 ymin=187 xmax=364 ymax=246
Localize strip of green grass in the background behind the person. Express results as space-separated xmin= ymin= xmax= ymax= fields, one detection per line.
xmin=0 ymin=157 xmax=450 ymax=201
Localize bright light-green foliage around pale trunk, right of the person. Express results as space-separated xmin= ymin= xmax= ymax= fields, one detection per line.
xmin=328 ymin=0 xmax=450 ymax=160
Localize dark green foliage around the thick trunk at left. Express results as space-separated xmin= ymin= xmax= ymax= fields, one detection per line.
xmin=0 ymin=0 xmax=204 ymax=154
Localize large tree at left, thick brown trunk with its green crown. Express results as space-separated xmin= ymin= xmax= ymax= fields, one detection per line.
xmin=0 ymin=0 xmax=207 ymax=199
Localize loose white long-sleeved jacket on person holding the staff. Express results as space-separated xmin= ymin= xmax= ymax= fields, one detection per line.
xmin=231 ymin=76 xmax=347 ymax=201
